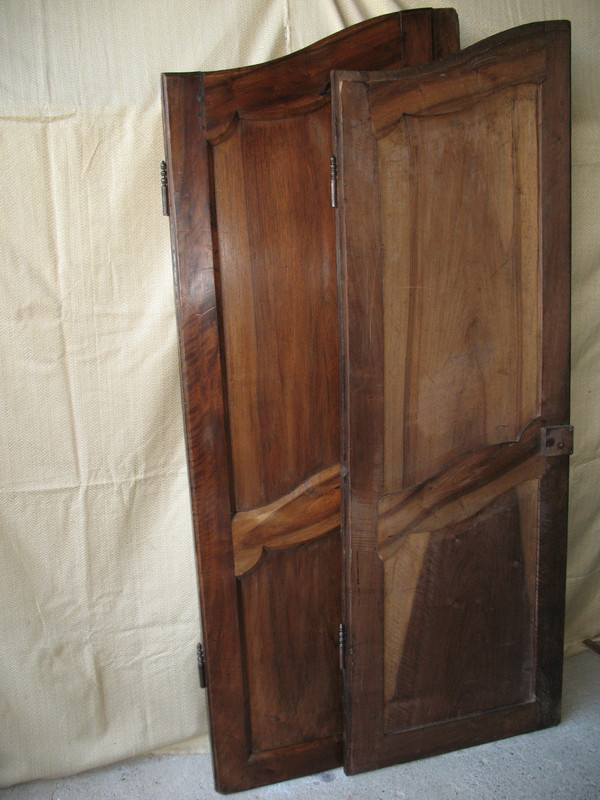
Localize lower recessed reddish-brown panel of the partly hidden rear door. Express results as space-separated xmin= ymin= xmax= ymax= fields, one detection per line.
xmin=240 ymin=528 xmax=342 ymax=752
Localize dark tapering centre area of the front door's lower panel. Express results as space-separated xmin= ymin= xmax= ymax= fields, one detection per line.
xmin=385 ymin=489 xmax=534 ymax=732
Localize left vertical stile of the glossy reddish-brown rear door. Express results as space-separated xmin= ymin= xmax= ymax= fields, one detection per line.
xmin=163 ymin=75 xmax=247 ymax=788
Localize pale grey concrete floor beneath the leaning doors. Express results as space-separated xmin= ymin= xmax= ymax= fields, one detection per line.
xmin=0 ymin=650 xmax=600 ymax=800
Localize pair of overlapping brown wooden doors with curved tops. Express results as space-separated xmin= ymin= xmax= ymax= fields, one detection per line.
xmin=163 ymin=10 xmax=571 ymax=791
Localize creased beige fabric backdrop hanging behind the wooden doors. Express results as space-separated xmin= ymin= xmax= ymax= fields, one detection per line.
xmin=0 ymin=0 xmax=600 ymax=785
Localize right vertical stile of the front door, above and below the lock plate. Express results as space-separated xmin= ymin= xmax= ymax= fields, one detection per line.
xmin=536 ymin=22 xmax=571 ymax=727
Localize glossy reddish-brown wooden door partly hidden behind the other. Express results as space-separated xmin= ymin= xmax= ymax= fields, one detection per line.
xmin=163 ymin=10 xmax=458 ymax=791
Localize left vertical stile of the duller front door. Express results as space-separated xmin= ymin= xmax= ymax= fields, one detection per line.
xmin=332 ymin=72 xmax=383 ymax=772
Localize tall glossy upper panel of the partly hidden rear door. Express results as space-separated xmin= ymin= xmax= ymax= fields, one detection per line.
xmin=212 ymin=106 xmax=339 ymax=511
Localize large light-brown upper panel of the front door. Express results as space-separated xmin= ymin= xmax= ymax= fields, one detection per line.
xmin=377 ymin=85 xmax=541 ymax=492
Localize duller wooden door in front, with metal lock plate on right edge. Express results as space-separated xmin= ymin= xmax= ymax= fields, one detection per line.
xmin=333 ymin=22 xmax=571 ymax=773
